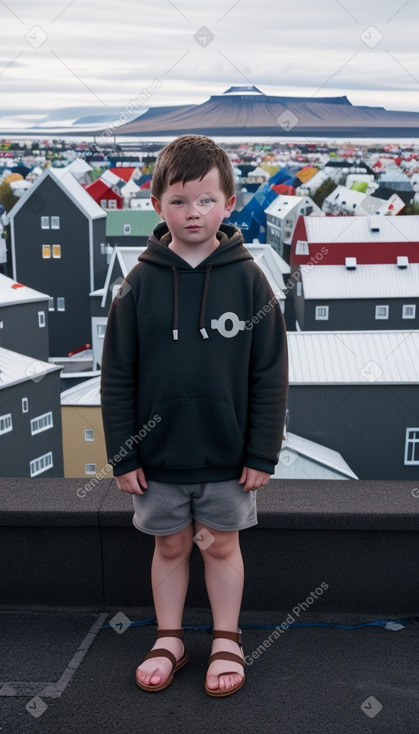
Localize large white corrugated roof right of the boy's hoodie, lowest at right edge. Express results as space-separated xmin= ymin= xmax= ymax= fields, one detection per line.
xmin=288 ymin=330 xmax=419 ymax=385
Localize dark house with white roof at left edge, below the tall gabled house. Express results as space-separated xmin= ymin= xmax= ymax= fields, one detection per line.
xmin=0 ymin=274 xmax=50 ymax=361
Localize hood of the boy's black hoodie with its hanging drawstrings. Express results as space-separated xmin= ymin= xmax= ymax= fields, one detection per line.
xmin=138 ymin=222 xmax=253 ymax=341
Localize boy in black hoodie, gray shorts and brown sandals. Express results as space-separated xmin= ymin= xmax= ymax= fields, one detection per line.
xmin=102 ymin=135 xmax=287 ymax=696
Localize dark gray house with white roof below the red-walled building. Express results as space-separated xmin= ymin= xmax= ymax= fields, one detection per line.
xmin=293 ymin=257 xmax=419 ymax=331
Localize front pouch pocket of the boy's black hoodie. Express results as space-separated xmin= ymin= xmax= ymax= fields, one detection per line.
xmin=140 ymin=399 xmax=244 ymax=469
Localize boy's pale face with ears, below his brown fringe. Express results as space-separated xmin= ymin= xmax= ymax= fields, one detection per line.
xmin=151 ymin=168 xmax=236 ymax=254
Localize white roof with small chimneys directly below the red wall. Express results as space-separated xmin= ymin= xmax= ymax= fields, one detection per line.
xmin=301 ymin=263 xmax=419 ymax=299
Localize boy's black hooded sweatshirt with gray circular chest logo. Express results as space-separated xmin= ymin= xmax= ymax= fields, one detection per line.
xmin=102 ymin=223 xmax=288 ymax=483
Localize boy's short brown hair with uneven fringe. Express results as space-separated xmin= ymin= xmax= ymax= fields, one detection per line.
xmin=151 ymin=135 xmax=234 ymax=199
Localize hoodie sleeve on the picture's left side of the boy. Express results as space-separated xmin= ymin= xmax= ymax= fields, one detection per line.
xmin=101 ymin=289 xmax=140 ymax=476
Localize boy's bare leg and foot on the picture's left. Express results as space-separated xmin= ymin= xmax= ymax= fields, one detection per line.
xmin=139 ymin=524 xmax=193 ymax=686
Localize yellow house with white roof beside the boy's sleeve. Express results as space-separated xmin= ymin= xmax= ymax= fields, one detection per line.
xmin=61 ymin=377 xmax=107 ymax=478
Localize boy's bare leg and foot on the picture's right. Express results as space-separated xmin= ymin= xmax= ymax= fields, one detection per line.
xmin=195 ymin=522 xmax=244 ymax=690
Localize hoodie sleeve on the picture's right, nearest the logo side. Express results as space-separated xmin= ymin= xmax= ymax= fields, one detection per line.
xmin=245 ymin=273 xmax=288 ymax=474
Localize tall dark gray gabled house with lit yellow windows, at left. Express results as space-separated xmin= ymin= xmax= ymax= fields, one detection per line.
xmin=7 ymin=168 xmax=107 ymax=357
